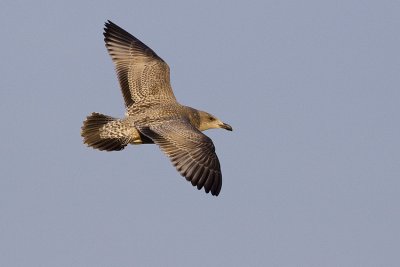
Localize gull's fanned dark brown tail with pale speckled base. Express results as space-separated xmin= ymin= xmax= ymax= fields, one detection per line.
xmin=81 ymin=112 xmax=130 ymax=151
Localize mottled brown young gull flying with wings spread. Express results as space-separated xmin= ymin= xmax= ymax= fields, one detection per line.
xmin=81 ymin=21 xmax=232 ymax=196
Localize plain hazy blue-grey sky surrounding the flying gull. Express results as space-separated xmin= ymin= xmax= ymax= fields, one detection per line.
xmin=0 ymin=0 xmax=400 ymax=267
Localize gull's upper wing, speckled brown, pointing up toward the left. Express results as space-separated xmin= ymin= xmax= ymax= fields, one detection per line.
xmin=104 ymin=21 xmax=176 ymax=107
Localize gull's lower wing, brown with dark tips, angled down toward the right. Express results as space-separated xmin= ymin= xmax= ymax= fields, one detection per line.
xmin=139 ymin=120 xmax=222 ymax=196
